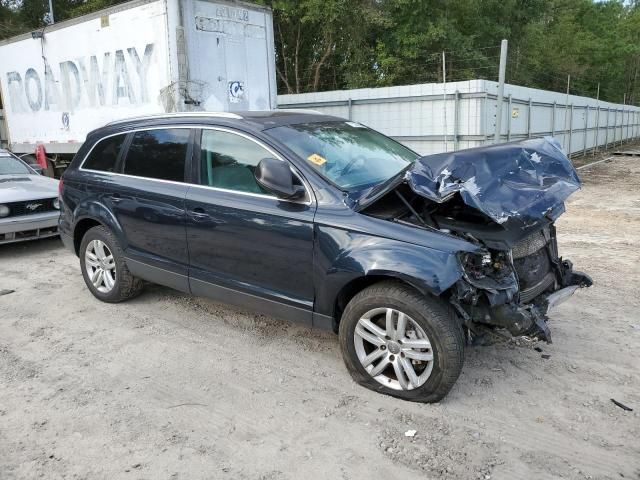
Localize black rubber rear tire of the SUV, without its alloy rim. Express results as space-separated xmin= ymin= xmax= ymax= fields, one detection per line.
xmin=79 ymin=226 xmax=143 ymax=303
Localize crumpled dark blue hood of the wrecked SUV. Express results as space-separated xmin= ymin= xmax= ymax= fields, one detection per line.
xmin=405 ymin=137 xmax=580 ymax=228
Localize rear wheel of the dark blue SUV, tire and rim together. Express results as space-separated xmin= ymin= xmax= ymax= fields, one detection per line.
xmin=80 ymin=226 xmax=143 ymax=303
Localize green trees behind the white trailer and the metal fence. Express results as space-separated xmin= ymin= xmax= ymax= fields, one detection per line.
xmin=0 ymin=0 xmax=640 ymax=104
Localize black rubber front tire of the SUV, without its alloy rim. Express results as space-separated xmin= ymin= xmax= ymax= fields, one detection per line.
xmin=339 ymin=281 xmax=465 ymax=403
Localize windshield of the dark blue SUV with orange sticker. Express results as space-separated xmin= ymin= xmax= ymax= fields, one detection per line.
xmin=265 ymin=122 xmax=418 ymax=190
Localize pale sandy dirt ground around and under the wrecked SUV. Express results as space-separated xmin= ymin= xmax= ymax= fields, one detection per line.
xmin=0 ymin=157 xmax=640 ymax=480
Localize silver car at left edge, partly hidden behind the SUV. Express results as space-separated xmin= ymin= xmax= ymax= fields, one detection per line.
xmin=0 ymin=149 xmax=60 ymax=248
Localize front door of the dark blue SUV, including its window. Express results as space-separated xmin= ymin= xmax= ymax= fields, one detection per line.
xmin=186 ymin=129 xmax=315 ymax=323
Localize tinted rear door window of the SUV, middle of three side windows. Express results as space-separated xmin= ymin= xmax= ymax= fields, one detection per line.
xmin=124 ymin=128 xmax=191 ymax=182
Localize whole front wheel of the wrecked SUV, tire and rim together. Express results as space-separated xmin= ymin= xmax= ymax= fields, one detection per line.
xmin=339 ymin=281 xmax=465 ymax=403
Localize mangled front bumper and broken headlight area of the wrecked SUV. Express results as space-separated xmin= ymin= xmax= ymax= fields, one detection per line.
xmin=450 ymin=229 xmax=593 ymax=343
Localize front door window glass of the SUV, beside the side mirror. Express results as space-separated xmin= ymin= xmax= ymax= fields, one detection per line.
xmin=200 ymin=130 xmax=273 ymax=194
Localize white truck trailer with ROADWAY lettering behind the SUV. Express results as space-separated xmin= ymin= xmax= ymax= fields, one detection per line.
xmin=0 ymin=0 xmax=276 ymax=174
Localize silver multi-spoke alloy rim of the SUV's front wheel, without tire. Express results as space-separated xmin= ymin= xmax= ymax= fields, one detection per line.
xmin=353 ymin=307 xmax=433 ymax=390
